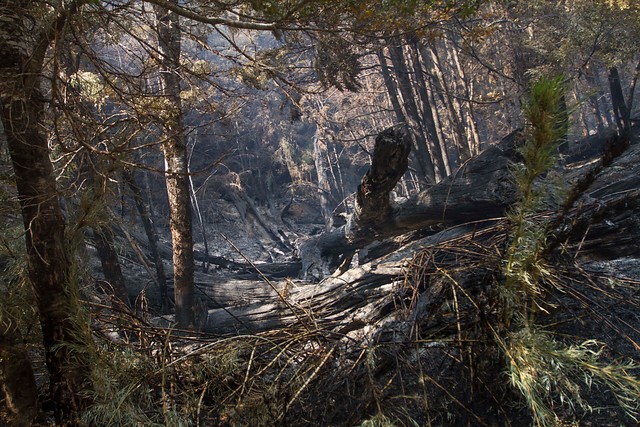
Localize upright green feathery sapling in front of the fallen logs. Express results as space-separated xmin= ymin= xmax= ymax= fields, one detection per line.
xmin=496 ymin=77 xmax=640 ymax=426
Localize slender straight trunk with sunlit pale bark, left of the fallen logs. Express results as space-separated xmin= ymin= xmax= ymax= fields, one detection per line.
xmin=155 ymin=0 xmax=194 ymax=328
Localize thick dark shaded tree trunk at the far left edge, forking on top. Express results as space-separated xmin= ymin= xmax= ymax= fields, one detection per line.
xmin=0 ymin=1 xmax=91 ymax=425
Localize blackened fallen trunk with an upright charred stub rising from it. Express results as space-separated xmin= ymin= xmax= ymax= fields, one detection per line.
xmin=299 ymin=129 xmax=521 ymax=279
